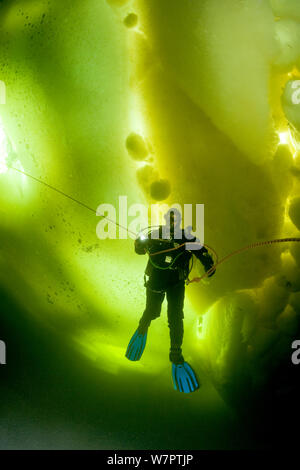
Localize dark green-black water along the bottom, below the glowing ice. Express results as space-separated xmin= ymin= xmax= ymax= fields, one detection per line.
xmin=0 ymin=282 xmax=300 ymax=450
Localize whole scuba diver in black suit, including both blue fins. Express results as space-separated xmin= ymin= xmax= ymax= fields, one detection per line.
xmin=125 ymin=208 xmax=215 ymax=393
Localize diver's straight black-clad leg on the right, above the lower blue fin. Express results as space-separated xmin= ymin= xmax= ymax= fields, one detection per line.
xmin=167 ymin=281 xmax=185 ymax=364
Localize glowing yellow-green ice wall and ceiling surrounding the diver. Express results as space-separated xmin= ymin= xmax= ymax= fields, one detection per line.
xmin=0 ymin=0 xmax=300 ymax=404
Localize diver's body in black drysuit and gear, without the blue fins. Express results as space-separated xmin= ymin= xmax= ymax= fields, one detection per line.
xmin=135 ymin=209 xmax=215 ymax=364
